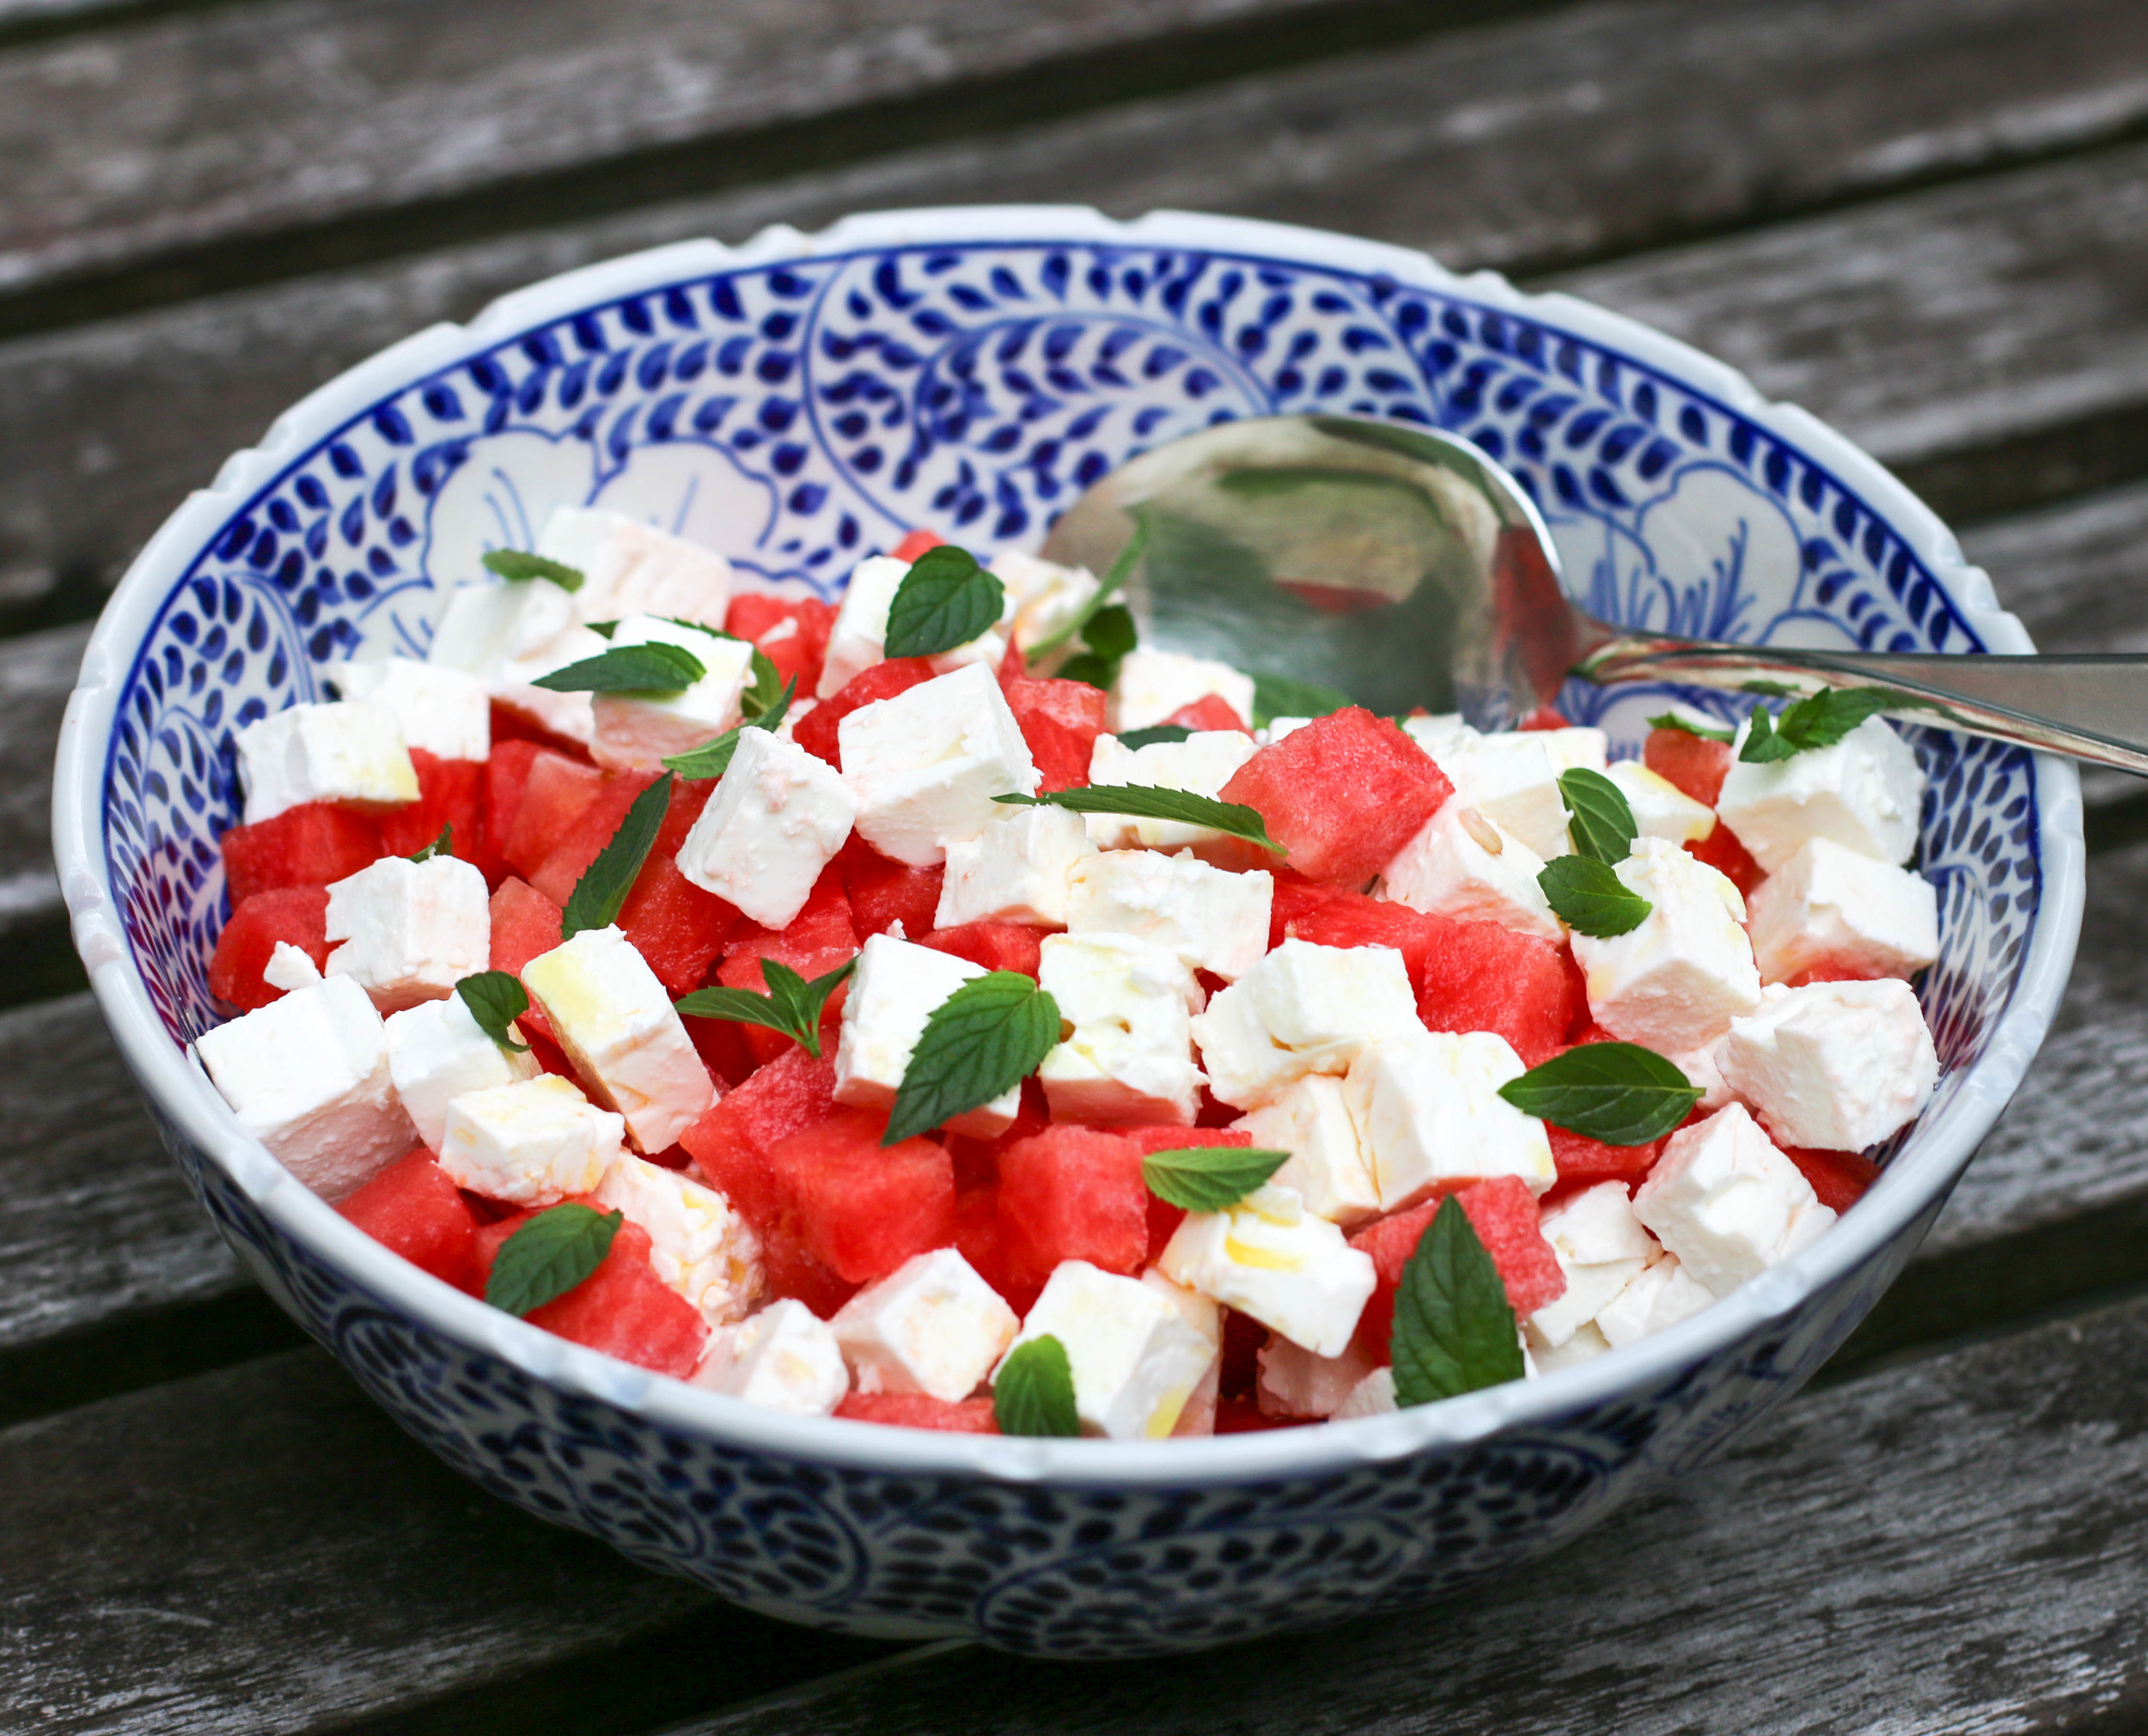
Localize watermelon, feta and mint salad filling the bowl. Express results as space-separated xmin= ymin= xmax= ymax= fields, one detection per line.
xmin=196 ymin=509 xmax=1937 ymax=1440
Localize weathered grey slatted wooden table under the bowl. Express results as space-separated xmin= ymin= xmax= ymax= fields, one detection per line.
xmin=12 ymin=0 xmax=2148 ymax=1736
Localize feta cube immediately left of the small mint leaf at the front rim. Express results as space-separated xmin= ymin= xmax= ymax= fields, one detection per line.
xmin=829 ymin=1248 xmax=1021 ymax=1403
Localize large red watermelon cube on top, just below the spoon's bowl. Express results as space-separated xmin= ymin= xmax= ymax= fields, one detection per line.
xmin=1223 ymin=704 xmax=1455 ymax=886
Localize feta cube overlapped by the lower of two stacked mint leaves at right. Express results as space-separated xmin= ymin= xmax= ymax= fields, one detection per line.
xmin=1575 ymin=838 xmax=1760 ymax=1053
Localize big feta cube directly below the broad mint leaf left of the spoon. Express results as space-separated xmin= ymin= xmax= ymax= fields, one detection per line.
xmin=836 ymin=664 xmax=1038 ymax=868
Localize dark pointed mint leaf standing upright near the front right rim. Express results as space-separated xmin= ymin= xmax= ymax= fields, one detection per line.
xmin=1392 ymin=1195 xmax=1525 ymax=1405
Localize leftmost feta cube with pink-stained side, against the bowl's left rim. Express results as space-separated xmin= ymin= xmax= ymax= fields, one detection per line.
xmin=193 ymin=978 xmax=417 ymax=1205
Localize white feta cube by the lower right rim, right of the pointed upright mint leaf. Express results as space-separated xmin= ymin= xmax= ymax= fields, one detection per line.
xmin=1632 ymin=1102 xmax=1834 ymax=1295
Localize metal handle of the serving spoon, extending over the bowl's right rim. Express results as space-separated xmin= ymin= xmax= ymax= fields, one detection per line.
xmin=1572 ymin=636 xmax=2148 ymax=776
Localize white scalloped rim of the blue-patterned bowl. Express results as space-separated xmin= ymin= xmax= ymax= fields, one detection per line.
xmin=54 ymin=204 xmax=2086 ymax=1489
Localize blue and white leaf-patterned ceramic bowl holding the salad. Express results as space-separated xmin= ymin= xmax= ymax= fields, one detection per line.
xmin=54 ymin=206 xmax=2082 ymax=1656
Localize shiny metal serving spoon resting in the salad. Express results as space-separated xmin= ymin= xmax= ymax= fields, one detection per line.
xmin=1044 ymin=417 xmax=2148 ymax=773
